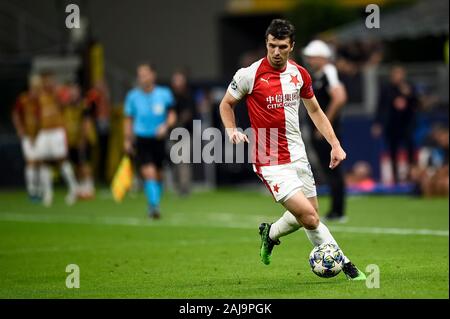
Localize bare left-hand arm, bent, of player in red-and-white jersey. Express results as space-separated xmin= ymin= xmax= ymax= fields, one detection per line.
xmin=219 ymin=92 xmax=248 ymax=144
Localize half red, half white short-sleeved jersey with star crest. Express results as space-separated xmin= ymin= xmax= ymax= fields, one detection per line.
xmin=228 ymin=57 xmax=314 ymax=166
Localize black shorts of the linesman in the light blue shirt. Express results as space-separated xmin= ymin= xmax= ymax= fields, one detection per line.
xmin=136 ymin=137 xmax=166 ymax=168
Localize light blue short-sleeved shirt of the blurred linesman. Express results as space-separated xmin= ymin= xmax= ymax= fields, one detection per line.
xmin=125 ymin=86 xmax=174 ymax=138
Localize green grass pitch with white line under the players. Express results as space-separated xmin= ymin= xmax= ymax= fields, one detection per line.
xmin=0 ymin=188 xmax=449 ymax=298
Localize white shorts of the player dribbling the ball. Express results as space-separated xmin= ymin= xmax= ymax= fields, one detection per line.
xmin=253 ymin=158 xmax=317 ymax=202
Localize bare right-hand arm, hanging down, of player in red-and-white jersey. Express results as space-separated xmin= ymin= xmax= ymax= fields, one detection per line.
xmin=302 ymin=96 xmax=347 ymax=169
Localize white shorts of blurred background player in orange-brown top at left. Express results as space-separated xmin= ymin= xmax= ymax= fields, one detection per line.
xmin=36 ymin=128 xmax=67 ymax=161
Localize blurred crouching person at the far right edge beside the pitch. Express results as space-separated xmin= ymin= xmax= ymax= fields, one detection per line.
xmin=411 ymin=126 xmax=449 ymax=197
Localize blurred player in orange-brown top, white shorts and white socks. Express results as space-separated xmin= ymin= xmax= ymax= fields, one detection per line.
xmin=36 ymin=71 xmax=78 ymax=206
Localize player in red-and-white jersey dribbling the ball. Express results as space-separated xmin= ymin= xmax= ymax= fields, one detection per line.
xmin=220 ymin=19 xmax=365 ymax=280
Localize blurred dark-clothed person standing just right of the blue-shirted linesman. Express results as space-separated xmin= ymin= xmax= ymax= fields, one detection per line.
xmin=171 ymin=70 xmax=195 ymax=196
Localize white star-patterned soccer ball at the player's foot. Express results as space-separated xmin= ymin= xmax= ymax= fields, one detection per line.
xmin=309 ymin=243 xmax=344 ymax=278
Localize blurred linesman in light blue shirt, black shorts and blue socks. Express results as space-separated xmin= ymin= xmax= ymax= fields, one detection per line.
xmin=124 ymin=63 xmax=177 ymax=219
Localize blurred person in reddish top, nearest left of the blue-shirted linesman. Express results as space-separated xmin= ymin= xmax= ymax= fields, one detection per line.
xmin=86 ymin=80 xmax=111 ymax=183
